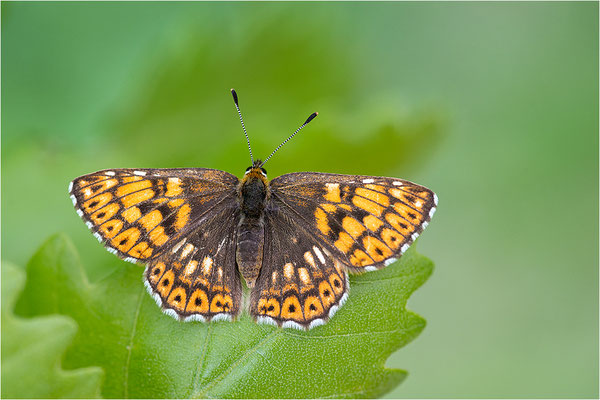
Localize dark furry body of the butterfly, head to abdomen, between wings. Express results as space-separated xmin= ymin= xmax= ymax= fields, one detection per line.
xmin=236 ymin=163 xmax=269 ymax=287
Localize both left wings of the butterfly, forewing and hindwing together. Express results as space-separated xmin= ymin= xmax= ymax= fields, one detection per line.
xmin=69 ymin=168 xmax=241 ymax=320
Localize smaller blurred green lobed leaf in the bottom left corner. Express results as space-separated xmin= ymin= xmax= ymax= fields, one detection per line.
xmin=2 ymin=262 xmax=102 ymax=398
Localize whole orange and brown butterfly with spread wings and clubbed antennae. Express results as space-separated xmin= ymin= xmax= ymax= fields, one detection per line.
xmin=69 ymin=89 xmax=437 ymax=329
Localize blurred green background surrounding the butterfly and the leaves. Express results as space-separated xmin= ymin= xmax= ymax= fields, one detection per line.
xmin=2 ymin=2 xmax=598 ymax=398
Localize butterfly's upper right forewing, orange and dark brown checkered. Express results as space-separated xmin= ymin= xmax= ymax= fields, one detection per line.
xmin=269 ymin=172 xmax=437 ymax=272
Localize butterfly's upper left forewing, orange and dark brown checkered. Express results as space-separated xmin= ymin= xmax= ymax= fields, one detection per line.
xmin=69 ymin=168 xmax=239 ymax=262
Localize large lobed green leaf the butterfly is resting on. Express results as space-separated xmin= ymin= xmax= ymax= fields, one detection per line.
xmin=19 ymin=235 xmax=433 ymax=398
